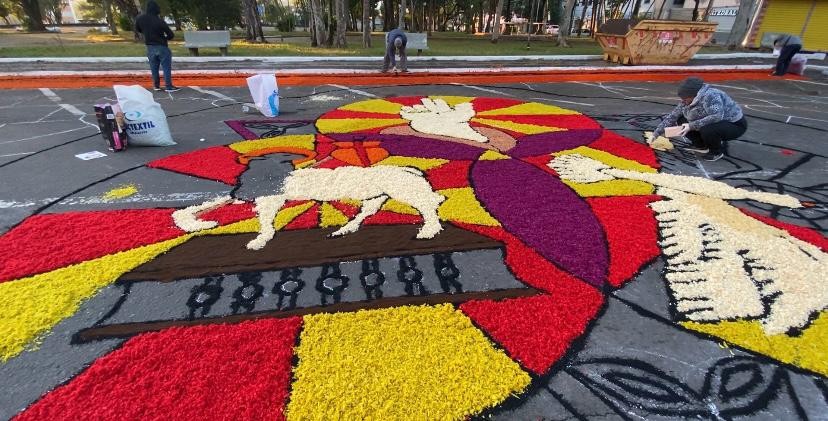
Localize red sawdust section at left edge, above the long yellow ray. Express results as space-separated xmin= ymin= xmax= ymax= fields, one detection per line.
xmin=0 ymin=209 xmax=183 ymax=282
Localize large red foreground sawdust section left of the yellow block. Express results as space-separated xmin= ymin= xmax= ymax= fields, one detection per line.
xmin=15 ymin=317 xmax=302 ymax=421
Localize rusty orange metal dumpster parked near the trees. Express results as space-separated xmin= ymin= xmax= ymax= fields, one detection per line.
xmin=595 ymin=19 xmax=718 ymax=64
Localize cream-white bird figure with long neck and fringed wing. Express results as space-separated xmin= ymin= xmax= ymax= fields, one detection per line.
xmin=549 ymin=154 xmax=828 ymax=335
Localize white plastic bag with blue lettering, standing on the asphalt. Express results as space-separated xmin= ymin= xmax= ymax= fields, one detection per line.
xmin=114 ymin=85 xmax=175 ymax=146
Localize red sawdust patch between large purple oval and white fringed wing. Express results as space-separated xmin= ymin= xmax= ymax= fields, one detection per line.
xmin=587 ymin=196 xmax=661 ymax=287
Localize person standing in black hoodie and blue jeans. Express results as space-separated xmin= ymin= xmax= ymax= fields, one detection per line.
xmin=135 ymin=0 xmax=179 ymax=92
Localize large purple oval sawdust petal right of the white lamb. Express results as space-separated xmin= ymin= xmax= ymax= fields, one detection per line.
xmin=471 ymin=159 xmax=609 ymax=286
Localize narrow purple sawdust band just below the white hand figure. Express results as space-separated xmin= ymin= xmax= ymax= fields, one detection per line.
xmin=328 ymin=133 xmax=485 ymax=160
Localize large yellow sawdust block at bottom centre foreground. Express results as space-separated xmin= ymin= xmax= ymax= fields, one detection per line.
xmin=287 ymin=304 xmax=530 ymax=420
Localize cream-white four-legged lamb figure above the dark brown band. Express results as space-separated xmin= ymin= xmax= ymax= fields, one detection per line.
xmin=173 ymin=154 xmax=446 ymax=250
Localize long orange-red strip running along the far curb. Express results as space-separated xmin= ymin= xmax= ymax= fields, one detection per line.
xmin=0 ymin=67 xmax=803 ymax=89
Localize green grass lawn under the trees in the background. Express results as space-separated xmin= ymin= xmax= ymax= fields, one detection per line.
xmin=0 ymin=33 xmax=601 ymax=57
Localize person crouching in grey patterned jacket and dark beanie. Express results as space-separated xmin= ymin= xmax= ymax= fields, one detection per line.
xmin=653 ymin=77 xmax=747 ymax=161
